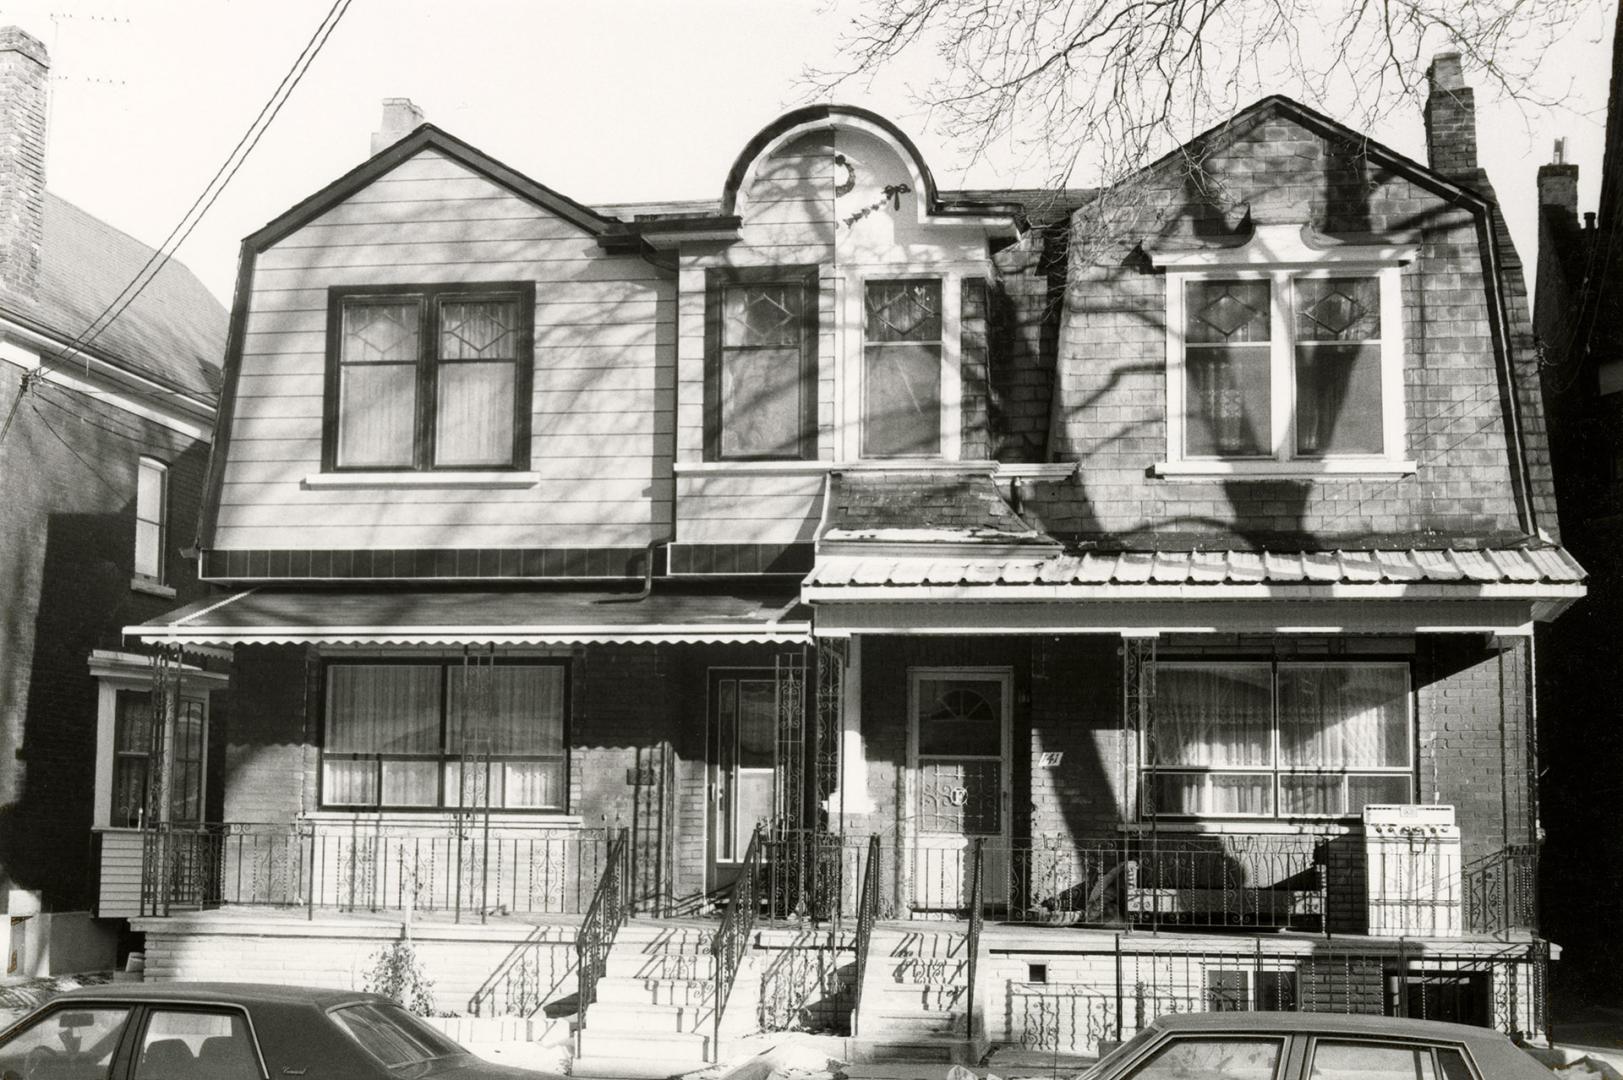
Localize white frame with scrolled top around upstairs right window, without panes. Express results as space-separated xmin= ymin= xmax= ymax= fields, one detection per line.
xmin=1151 ymin=226 xmax=1417 ymax=477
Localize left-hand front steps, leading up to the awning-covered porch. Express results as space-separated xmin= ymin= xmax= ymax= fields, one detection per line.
xmin=571 ymin=921 xmax=716 ymax=1077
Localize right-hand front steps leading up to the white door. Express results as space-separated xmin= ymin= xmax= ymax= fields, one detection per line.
xmin=852 ymin=926 xmax=977 ymax=1064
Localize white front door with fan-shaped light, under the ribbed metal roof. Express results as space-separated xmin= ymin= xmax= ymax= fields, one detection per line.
xmin=907 ymin=667 xmax=1011 ymax=911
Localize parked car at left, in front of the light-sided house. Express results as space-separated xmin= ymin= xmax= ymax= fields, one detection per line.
xmin=0 ymin=983 xmax=550 ymax=1080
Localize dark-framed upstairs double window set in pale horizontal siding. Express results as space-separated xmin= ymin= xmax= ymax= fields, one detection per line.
xmin=323 ymin=283 xmax=536 ymax=471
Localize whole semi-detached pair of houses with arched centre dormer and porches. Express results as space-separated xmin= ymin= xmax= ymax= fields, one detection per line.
xmin=131 ymin=57 xmax=1584 ymax=1061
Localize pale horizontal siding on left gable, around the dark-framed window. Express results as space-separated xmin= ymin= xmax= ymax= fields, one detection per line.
xmin=214 ymin=151 xmax=677 ymax=551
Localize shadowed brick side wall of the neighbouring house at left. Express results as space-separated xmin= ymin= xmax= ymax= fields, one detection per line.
xmin=0 ymin=364 xmax=208 ymax=911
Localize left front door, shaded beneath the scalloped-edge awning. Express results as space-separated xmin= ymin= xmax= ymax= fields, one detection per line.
xmin=706 ymin=667 xmax=777 ymax=890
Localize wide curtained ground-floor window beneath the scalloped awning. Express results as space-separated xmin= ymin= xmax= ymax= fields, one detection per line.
xmin=321 ymin=661 xmax=568 ymax=810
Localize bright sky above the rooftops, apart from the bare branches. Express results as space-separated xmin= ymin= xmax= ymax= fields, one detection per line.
xmin=0 ymin=0 xmax=1617 ymax=304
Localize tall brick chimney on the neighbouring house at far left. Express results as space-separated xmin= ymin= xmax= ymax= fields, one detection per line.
xmin=0 ymin=26 xmax=50 ymax=299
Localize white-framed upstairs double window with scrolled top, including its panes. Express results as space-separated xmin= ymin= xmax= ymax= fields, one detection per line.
xmin=1152 ymin=226 xmax=1414 ymax=476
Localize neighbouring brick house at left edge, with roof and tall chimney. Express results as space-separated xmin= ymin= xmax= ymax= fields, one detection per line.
xmin=0 ymin=28 xmax=226 ymax=973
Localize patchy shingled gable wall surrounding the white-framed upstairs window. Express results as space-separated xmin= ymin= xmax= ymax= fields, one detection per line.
xmin=1027 ymin=103 xmax=1537 ymax=546
